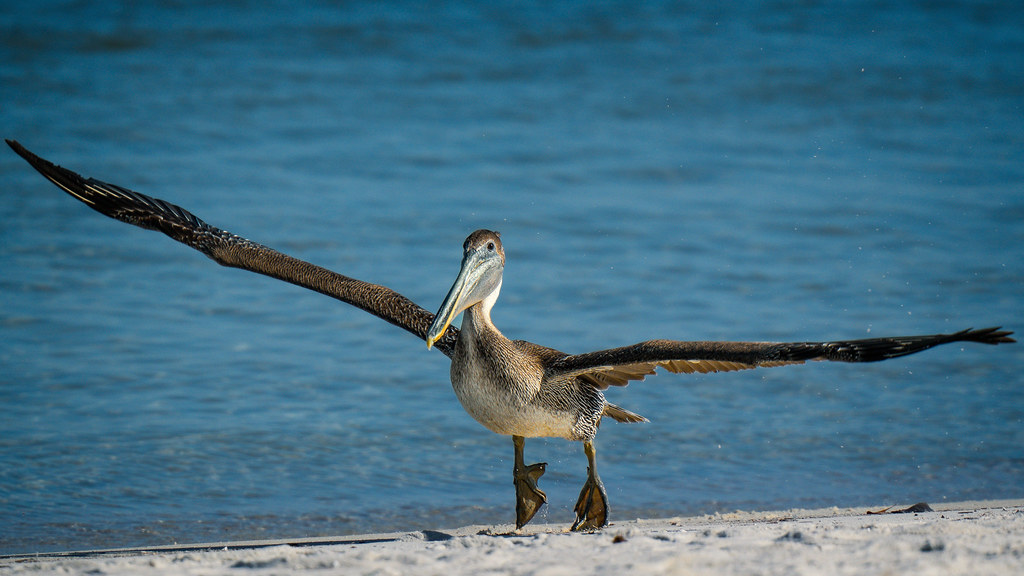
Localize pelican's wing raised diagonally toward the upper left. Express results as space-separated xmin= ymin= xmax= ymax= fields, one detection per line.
xmin=6 ymin=140 xmax=459 ymax=357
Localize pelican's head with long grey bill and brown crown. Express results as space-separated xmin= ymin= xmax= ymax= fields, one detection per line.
xmin=427 ymin=230 xmax=505 ymax=347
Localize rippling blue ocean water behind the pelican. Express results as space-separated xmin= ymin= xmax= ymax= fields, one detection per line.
xmin=0 ymin=0 xmax=1024 ymax=553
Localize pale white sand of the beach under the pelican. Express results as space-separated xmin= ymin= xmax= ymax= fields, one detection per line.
xmin=0 ymin=500 xmax=1024 ymax=576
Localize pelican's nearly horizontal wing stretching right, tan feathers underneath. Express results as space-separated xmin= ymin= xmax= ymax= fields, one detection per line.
xmin=546 ymin=328 xmax=1016 ymax=389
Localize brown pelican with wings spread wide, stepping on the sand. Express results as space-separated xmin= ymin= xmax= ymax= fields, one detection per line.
xmin=7 ymin=140 xmax=1015 ymax=530
